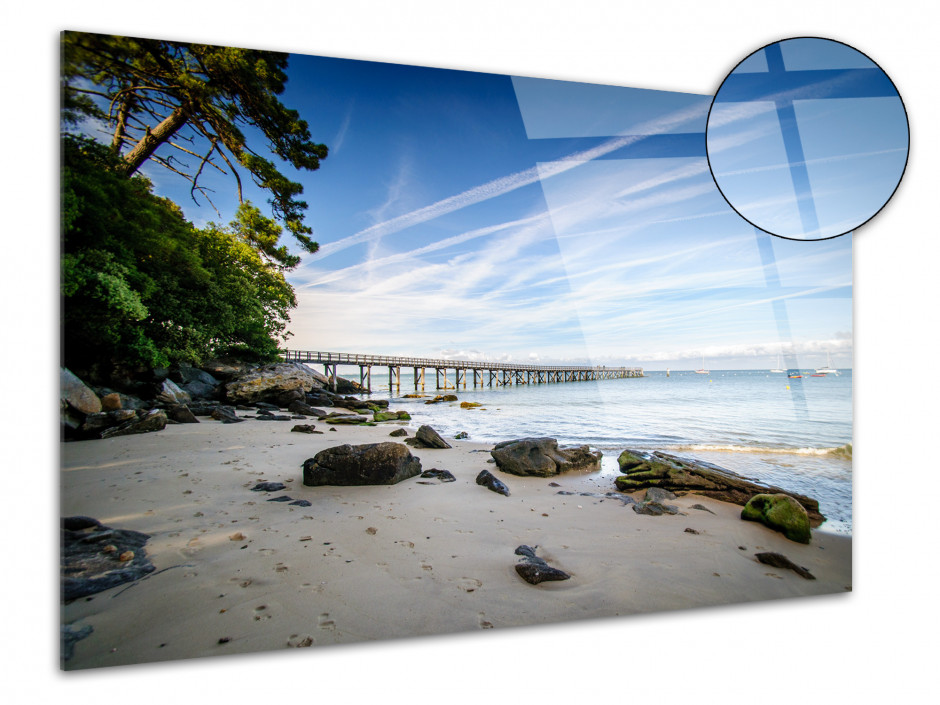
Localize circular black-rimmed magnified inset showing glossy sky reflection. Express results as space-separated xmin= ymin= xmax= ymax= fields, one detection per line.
xmin=705 ymin=37 xmax=910 ymax=240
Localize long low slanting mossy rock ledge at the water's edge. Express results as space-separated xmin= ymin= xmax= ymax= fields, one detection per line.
xmin=615 ymin=450 xmax=826 ymax=526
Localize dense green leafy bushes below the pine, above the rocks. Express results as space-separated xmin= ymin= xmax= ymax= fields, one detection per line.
xmin=62 ymin=137 xmax=296 ymax=369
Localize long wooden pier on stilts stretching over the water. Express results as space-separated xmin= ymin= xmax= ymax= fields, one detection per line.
xmin=282 ymin=350 xmax=643 ymax=392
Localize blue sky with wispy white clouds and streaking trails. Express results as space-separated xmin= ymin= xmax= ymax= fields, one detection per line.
xmin=119 ymin=48 xmax=852 ymax=369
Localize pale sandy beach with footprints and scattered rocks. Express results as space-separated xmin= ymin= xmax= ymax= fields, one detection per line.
xmin=61 ymin=419 xmax=852 ymax=670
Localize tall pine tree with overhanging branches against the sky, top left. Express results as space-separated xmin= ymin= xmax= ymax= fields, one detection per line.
xmin=62 ymin=27 xmax=328 ymax=268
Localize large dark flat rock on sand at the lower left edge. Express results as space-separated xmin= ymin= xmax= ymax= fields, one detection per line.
xmin=61 ymin=516 xmax=154 ymax=601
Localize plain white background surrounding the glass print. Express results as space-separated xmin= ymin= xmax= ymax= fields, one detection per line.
xmin=0 ymin=0 xmax=940 ymax=703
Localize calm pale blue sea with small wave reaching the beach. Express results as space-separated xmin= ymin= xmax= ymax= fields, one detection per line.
xmin=352 ymin=368 xmax=852 ymax=534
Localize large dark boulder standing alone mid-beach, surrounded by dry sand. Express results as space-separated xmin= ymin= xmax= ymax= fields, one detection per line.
xmin=303 ymin=441 xmax=421 ymax=486
